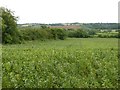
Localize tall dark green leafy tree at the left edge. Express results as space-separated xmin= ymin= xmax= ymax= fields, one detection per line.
xmin=0 ymin=7 xmax=21 ymax=44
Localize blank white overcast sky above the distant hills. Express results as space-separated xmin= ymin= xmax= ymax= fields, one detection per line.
xmin=0 ymin=0 xmax=120 ymax=24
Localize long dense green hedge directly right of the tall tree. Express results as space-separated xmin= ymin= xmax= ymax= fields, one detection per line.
xmin=20 ymin=27 xmax=66 ymax=40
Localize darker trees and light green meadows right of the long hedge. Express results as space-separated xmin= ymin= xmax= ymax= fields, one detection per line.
xmin=67 ymin=28 xmax=120 ymax=38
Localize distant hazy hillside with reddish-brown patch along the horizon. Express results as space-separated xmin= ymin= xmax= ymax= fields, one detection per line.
xmin=18 ymin=23 xmax=120 ymax=29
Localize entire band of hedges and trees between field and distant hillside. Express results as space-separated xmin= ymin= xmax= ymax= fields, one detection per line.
xmin=19 ymin=26 xmax=119 ymax=43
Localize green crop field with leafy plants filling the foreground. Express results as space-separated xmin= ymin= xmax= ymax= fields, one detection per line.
xmin=2 ymin=38 xmax=118 ymax=88
